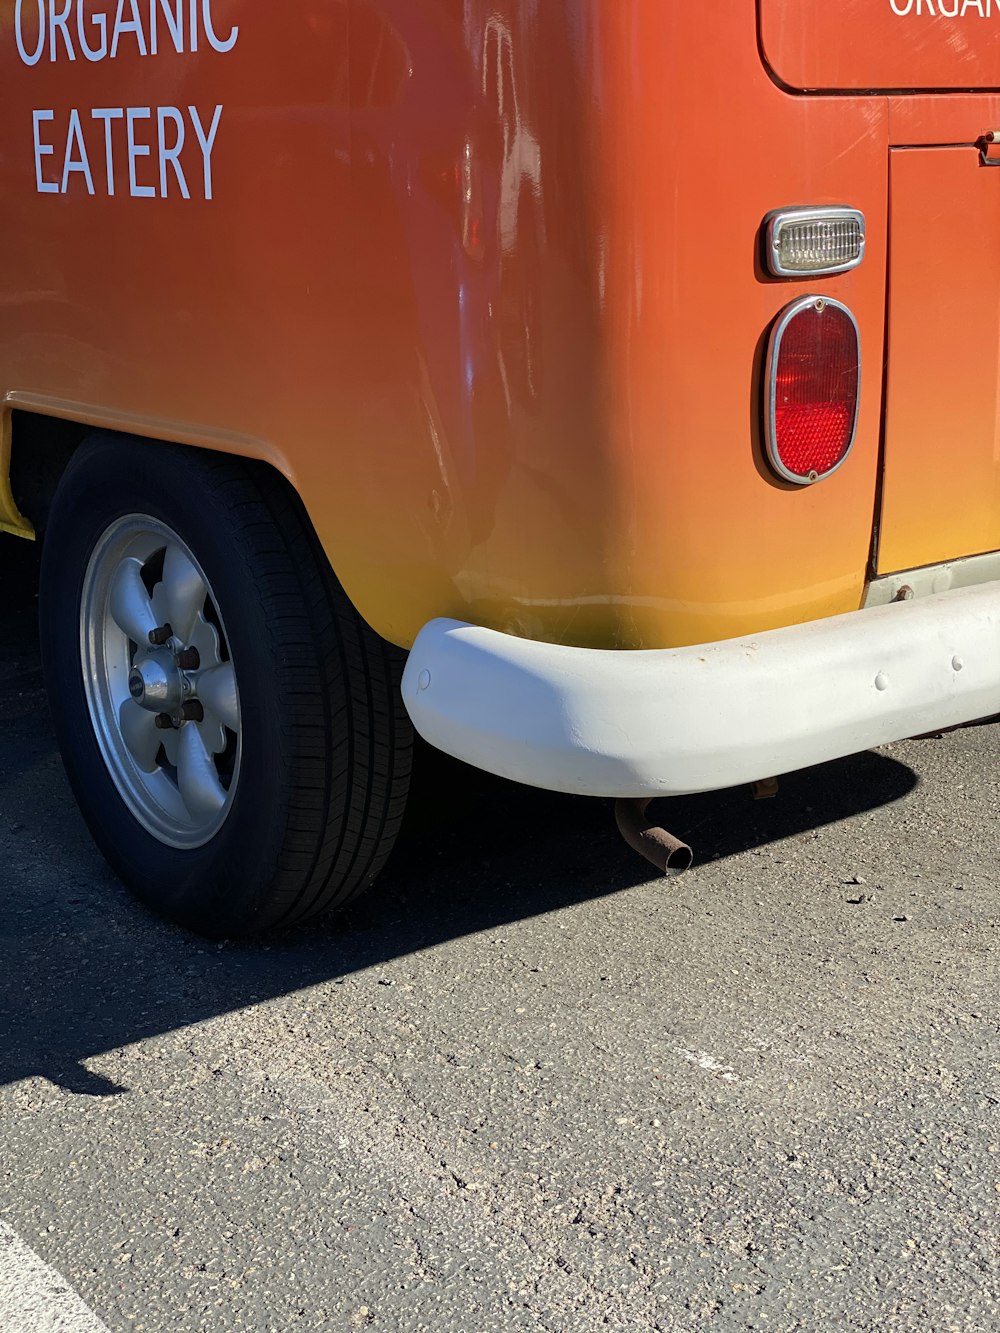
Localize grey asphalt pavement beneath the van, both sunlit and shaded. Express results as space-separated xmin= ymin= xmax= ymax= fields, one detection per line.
xmin=0 ymin=539 xmax=1000 ymax=1333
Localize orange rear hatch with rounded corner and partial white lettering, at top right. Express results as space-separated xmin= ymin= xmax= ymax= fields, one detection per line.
xmin=759 ymin=0 xmax=1000 ymax=92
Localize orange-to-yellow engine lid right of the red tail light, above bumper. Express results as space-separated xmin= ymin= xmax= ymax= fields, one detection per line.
xmin=879 ymin=147 xmax=1000 ymax=573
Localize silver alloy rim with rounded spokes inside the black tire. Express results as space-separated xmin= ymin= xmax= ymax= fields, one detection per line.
xmin=80 ymin=515 xmax=243 ymax=849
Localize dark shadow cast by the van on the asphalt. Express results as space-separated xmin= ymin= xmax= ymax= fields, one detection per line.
xmin=0 ymin=535 xmax=916 ymax=1096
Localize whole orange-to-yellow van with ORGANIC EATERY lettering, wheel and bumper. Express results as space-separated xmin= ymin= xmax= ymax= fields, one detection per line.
xmin=0 ymin=0 xmax=1000 ymax=934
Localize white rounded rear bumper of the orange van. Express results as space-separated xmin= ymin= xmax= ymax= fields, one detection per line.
xmin=403 ymin=583 xmax=1000 ymax=797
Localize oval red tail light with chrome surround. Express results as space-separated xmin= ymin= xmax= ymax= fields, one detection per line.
xmin=767 ymin=296 xmax=861 ymax=485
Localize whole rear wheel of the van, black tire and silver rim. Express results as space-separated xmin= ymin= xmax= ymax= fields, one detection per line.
xmin=40 ymin=436 xmax=412 ymax=936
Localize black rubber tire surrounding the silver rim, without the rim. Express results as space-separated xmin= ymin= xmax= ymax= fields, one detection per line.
xmin=40 ymin=435 xmax=412 ymax=937
